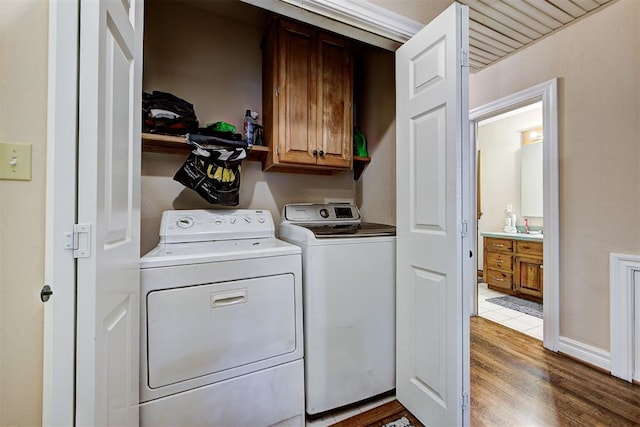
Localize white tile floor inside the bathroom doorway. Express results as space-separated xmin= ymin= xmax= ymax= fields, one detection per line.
xmin=478 ymin=283 xmax=542 ymax=341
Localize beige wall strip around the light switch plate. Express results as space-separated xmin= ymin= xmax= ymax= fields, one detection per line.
xmin=0 ymin=0 xmax=48 ymax=426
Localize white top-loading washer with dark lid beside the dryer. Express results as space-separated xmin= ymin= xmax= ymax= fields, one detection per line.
xmin=279 ymin=204 xmax=396 ymax=415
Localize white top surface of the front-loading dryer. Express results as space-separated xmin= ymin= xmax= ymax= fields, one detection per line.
xmin=140 ymin=237 xmax=301 ymax=268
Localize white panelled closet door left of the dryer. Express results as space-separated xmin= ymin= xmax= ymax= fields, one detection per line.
xmin=76 ymin=0 xmax=143 ymax=426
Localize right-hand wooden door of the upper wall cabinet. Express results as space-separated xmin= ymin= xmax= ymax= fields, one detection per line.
xmin=317 ymin=32 xmax=353 ymax=168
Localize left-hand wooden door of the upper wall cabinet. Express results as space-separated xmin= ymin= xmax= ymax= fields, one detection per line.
xmin=276 ymin=20 xmax=317 ymax=164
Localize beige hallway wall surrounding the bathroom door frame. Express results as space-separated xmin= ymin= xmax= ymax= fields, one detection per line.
xmin=470 ymin=0 xmax=640 ymax=350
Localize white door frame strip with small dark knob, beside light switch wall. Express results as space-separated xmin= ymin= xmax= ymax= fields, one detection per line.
xmin=42 ymin=1 xmax=80 ymax=425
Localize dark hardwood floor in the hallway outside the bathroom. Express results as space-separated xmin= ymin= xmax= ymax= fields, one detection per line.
xmin=471 ymin=317 xmax=640 ymax=427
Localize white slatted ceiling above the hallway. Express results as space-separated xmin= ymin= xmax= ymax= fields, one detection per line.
xmin=459 ymin=0 xmax=615 ymax=72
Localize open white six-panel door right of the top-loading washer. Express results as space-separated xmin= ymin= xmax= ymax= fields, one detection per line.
xmin=396 ymin=3 xmax=469 ymax=426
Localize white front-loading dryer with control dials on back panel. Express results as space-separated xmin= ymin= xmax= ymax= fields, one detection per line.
xmin=140 ymin=210 xmax=305 ymax=427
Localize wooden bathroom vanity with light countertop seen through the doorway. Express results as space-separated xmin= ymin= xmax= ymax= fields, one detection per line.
xmin=482 ymin=232 xmax=543 ymax=302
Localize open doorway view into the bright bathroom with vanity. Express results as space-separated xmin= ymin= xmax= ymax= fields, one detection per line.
xmin=476 ymin=101 xmax=544 ymax=341
